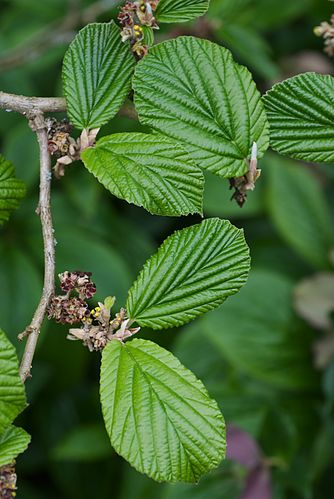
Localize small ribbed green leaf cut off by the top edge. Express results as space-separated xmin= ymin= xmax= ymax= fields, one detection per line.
xmin=155 ymin=0 xmax=209 ymax=23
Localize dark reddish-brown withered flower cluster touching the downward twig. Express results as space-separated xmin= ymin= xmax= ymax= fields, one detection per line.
xmin=48 ymin=270 xmax=96 ymax=324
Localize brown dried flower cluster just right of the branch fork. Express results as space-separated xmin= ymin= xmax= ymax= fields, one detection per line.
xmin=46 ymin=118 xmax=100 ymax=178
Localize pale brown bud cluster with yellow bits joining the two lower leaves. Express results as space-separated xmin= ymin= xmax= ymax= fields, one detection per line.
xmin=67 ymin=297 xmax=140 ymax=352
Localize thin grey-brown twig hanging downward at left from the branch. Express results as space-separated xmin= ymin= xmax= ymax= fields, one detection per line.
xmin=19 ymin=113 xmax=55 ymax=382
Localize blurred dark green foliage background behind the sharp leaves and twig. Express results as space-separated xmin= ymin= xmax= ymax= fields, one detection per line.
xmin=0 ymin=0 xmax=334 ymax=499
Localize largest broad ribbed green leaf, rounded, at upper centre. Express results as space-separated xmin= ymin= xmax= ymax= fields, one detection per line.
xmin=133 ymin=36 xmax=269 ymax=177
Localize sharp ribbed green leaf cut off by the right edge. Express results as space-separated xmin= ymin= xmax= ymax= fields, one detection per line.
xmin=264 ymin=73 xmax=334 ymax=163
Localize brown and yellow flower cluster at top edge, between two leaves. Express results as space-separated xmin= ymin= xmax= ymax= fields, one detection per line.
xmin=118 ymin=0 xmax=159 ymax=59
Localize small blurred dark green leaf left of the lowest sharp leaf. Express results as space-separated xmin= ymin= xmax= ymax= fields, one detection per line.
xmin=52 ymin=424 xmax=112 ymax=462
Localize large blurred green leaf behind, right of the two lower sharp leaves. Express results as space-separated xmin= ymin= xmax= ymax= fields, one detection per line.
xmin=202 ymin=270 xmax=315 ymax=390
